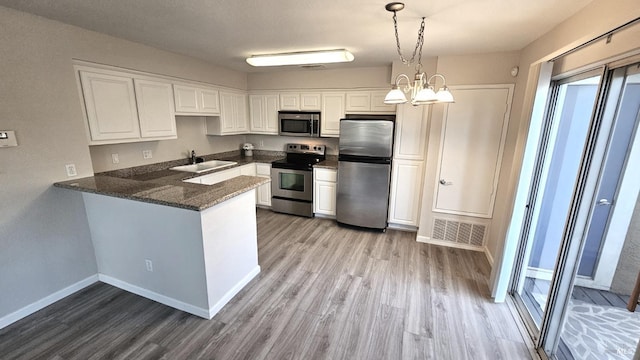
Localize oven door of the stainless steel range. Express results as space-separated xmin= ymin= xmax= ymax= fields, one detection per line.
xmin=271 ymin=168 xmax=313 ymax=201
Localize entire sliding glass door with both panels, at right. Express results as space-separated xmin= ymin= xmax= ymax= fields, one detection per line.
xmin=510 ymin=59 xmax=640 ymax=359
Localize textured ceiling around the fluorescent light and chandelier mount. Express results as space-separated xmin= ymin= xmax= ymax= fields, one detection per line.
xmin=0 ymin=0 xmax=591 ymax=72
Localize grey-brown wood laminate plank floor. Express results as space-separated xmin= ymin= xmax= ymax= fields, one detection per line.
xmin=0 ymin=209 xmax=532 ymax=360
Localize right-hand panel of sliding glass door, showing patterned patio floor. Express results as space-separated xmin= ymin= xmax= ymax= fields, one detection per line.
xmin=545 ymin=65 xmax=640 ymax=360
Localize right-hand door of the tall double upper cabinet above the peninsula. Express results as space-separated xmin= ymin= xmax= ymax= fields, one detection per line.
xmin=134 ymin=79 xmax=177 ymax=138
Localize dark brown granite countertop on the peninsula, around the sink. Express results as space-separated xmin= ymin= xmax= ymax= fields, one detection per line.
xmin=54 ymin=152 xmax=284 ymax=211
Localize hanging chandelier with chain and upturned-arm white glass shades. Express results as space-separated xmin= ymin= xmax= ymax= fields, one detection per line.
xmin=384 ymin=2 xmax=454 ymax=105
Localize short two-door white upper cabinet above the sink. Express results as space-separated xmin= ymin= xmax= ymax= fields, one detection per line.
xmin=173 ymin=84 xmax=220 ymax=115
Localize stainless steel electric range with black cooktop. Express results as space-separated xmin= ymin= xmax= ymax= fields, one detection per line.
xmin=271 ymin=144 xmax=325 ymax=217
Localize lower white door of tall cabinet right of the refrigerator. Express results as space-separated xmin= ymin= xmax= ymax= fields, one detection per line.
xmin=389 ymin=159 xmax=424 ymax=226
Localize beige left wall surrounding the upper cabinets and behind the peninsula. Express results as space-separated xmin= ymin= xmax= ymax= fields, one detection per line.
xmin=0 ymin=7 xmax=247 ymax=320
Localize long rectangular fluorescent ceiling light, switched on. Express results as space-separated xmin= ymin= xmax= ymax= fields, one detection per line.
xmin=247 ymin=49 xmax=353 ymax=66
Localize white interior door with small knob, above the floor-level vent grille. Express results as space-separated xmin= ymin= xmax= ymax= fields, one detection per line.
xmin=433 ymin=85 xmax=513 ymax=218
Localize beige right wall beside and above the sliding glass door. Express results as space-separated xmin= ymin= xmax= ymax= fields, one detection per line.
xmin=488 ymin=0 xmax=640 ymax=292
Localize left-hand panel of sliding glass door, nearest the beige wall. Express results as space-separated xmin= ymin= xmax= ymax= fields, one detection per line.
xmin=513 ymin=72 xmax=601 ymax=333
